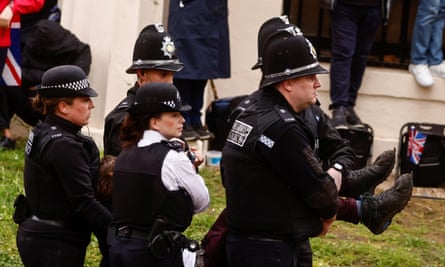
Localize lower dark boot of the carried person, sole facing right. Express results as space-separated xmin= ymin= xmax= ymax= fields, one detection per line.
xmin=361 ymin=173 xmax=413 ymax=235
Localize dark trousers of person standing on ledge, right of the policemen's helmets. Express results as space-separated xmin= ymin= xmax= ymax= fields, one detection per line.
xmin=330 ymin=1 xmax=381 ymax=108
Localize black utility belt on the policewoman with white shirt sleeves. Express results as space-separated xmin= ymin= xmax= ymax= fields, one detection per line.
xmin=107 ymin=219 xmax=200 ymax=259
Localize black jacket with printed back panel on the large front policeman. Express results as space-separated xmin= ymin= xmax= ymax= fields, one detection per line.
xmin=222 ymin=88 xmax=337 ymax=243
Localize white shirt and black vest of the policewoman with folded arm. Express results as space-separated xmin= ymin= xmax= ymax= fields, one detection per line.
xmin=113 ymin=130 xmax=209 ymax=232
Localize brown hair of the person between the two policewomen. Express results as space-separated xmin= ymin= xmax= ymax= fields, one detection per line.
xmin=96 ymin=155 xmax=116 ymax=202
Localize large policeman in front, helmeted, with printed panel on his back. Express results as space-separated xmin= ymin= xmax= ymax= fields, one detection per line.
xmin=222 ymin=26 xmax=412 ymax=266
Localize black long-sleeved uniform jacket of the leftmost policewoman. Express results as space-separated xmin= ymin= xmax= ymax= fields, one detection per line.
xmin=20 ymin=115 xmax=111 ymax=244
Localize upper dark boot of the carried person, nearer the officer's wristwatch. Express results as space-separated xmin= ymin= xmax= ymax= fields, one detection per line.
xmin=341 ymin=149 xmax=396 ymax=198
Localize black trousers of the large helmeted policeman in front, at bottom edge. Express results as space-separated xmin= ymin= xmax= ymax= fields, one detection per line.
xmin=226 ymin=233 xmax=312 ymax=267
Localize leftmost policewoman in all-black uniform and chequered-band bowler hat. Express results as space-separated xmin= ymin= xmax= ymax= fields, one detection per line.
xmin=17 ymin=65 xmax=111 ymax=267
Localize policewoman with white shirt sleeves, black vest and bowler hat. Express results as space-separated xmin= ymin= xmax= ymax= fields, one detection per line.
xmin=110 ymin=83 xmax=209 ymax=267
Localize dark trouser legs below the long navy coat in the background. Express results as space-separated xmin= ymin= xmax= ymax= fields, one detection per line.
xmin=173 ymin=79 xmax=207 ymax=126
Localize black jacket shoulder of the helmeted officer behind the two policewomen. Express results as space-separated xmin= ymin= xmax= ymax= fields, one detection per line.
xmin=103 ymin=82 xmax=139 ymax=156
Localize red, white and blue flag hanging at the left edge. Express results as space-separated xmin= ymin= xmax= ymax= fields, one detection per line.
xmin=0 ymin=22 xmax=22 ymax=86
